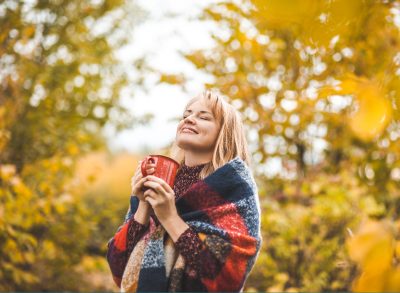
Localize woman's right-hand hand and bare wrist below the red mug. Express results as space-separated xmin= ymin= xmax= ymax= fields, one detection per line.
xmin=143 ymin=175 xmax=189 ymax=242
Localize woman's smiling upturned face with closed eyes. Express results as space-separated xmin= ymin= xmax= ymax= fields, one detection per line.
xmin=176 ymin=100 xmax=220 ymax=153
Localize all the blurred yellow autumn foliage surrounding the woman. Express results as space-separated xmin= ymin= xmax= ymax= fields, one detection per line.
xmin=0 ymin=0 xmax=400 ymax=292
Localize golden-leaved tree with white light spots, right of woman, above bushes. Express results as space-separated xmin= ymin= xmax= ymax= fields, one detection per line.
xmin=186 ymin=0 xmax=400 ymax=181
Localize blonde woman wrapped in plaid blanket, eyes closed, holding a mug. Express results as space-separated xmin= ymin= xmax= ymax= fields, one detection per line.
xmin=107 ymin=91 xmax=261 ymax=292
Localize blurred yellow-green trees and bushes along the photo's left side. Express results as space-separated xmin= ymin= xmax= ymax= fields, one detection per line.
xmin=0 ymin=0 xmax=142 ymax=291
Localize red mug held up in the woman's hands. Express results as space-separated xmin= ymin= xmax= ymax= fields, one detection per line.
xmin=141 ymin=155 xmax=179 ymax=187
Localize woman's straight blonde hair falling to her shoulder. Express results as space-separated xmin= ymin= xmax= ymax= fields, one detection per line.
xmin=171 ymin=90 xmax=250 ymax=179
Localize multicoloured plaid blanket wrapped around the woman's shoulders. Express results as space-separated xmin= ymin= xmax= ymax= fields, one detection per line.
xmin=121 ymin=158 xmax=261 ymax=292
